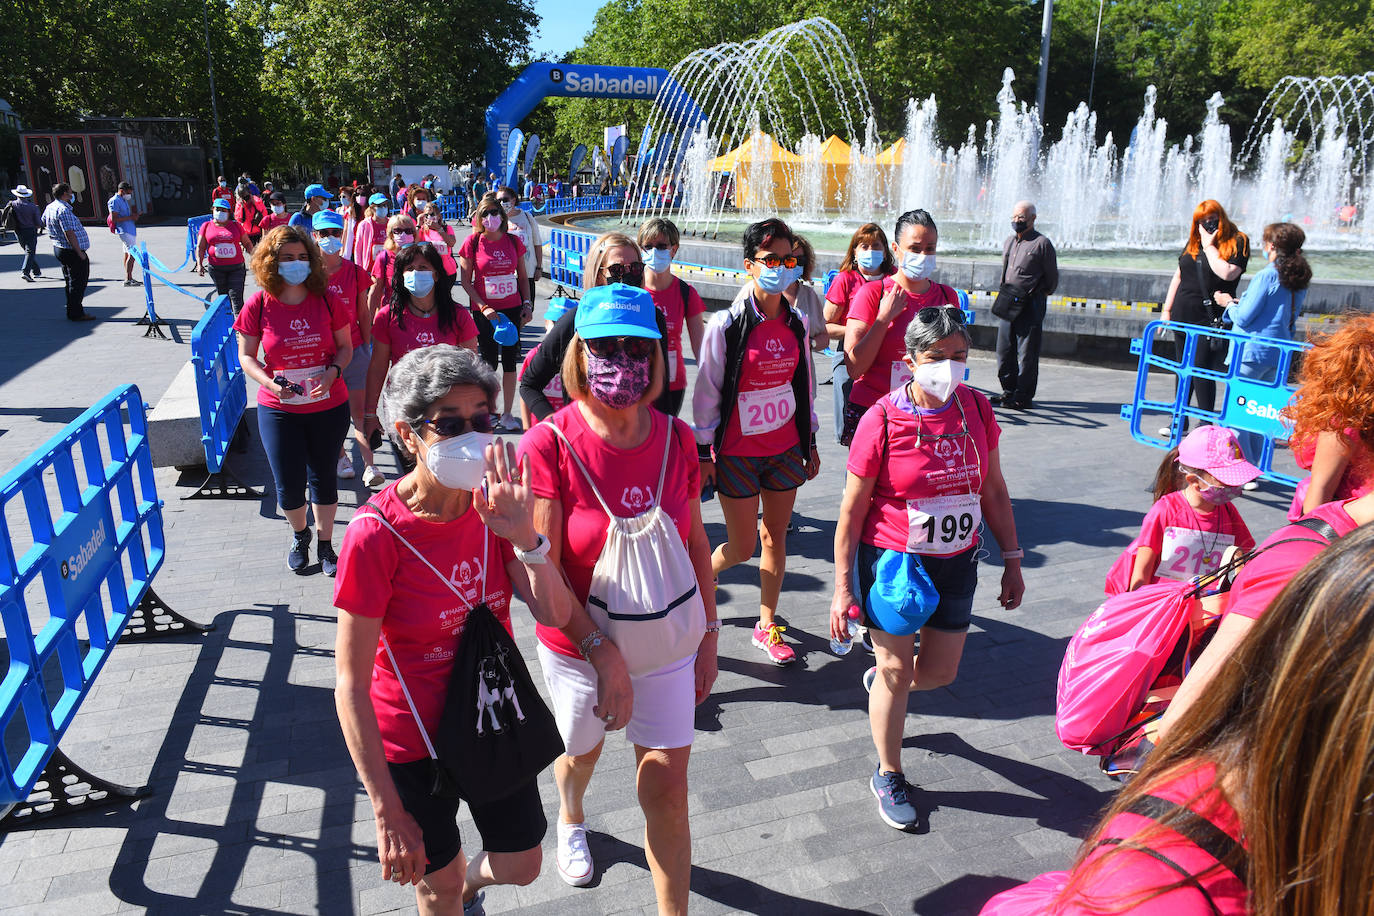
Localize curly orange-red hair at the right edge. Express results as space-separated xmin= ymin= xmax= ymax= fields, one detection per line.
xmin=1283 ymin=314 xmax=1374 ymax=455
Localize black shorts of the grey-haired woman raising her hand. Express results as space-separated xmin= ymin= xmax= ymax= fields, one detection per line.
xmin=386 ymin=759 xmax=548 ymax=875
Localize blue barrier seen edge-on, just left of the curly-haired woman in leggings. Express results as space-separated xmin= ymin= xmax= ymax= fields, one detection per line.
xmin=183 ymin=295 xmax=262 ymax=499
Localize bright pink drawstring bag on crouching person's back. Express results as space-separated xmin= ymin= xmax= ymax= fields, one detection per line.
xmin=1054 ymin=580 xmax=1197 ymax=754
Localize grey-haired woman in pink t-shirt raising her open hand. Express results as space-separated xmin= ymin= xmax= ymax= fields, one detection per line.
xmin=334 ymin=346 xmax=573 ymax=913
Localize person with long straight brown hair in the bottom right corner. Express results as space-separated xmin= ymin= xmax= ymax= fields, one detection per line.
xmin=982 ymin=521 xmax=1374 ymax=916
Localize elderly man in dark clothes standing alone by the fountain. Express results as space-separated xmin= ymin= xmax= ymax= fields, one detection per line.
xmin=991 ymin=201 xmax=1059 ymax=411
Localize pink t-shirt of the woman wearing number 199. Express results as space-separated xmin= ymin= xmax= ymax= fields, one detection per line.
xmin=848 ymin=385 xmax=1002 ymax=556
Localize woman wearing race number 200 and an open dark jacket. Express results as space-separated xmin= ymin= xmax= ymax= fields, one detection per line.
xmin=692 ymin=218 xmax=820 ymax=665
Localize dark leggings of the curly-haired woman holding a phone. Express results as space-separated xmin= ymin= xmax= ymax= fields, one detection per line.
xmin=257 ymin=401 xmax=349 ymax=512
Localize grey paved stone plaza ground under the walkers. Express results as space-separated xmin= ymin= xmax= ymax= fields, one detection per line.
xmin=0 ymin=227 xmax=1289 ymax=916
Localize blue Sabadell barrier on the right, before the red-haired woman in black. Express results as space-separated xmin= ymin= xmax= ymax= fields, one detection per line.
xmin=1121 ymin=321 xmax=1311 ymax=486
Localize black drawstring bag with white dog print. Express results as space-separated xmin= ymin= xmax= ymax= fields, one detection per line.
xmin=367 ymin=503 xmax=565 ymax=802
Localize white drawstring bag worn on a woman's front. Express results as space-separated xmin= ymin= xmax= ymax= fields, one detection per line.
xmin=551 ymin=417 xmax=706 ymax=677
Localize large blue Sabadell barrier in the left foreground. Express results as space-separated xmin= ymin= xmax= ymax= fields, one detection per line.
xmin=0 ymin=385 xmax=205 ymax=829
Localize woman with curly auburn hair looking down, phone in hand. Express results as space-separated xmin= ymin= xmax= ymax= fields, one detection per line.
xmin=234 ymin=225 xmax=353 ymax=575
